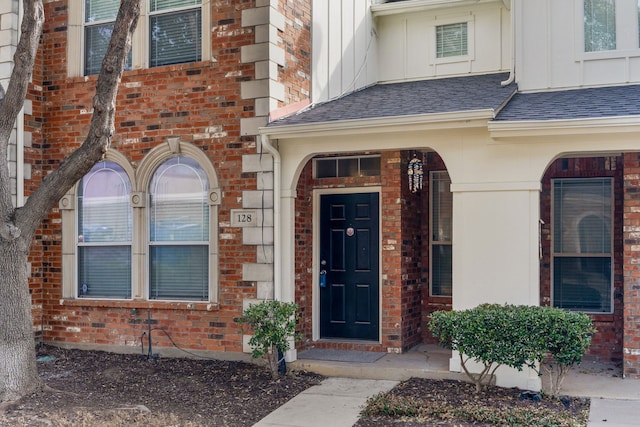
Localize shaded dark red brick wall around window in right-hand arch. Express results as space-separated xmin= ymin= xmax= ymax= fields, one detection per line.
xmin=540 ymin=157 xmax=626 ymax=362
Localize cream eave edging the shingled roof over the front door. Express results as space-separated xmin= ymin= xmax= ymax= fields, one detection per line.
xmin=259 ymin=109 xmax=495 ymax=139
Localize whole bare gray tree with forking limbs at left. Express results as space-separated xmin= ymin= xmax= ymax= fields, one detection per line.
xmin=0 ymin=0 xmax=141 ymax=403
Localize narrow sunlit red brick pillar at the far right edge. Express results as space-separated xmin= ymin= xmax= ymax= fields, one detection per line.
xmin=622 ymin=153 xmax=640 ymax=378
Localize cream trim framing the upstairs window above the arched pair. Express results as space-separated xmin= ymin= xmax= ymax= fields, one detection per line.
xmin=67 ymin=0 xmax=212 ymax=77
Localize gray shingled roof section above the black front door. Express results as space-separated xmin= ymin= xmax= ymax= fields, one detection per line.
xmin=269 ymin=73 xmax=517 ymax=127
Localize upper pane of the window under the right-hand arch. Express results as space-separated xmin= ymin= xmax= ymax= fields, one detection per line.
xmin=553 ymin=178 xmax=612 ymax=254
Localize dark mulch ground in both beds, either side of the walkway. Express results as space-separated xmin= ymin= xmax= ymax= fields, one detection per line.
xmin=0 ymin=346 xmax=600 ymax=427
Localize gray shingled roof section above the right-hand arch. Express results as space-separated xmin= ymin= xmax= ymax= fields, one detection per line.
xmin=495 ymin=85 xmax=640 ymax=122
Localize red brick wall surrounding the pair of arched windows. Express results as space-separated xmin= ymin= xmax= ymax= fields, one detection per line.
xmin=30 ymin=0 xmax=310 ymax=352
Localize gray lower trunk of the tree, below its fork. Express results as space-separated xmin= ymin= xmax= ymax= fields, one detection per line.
xmin=0 ymin=238 xmax=42 ymax=402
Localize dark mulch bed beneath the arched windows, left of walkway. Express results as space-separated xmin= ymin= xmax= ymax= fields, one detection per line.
xmin=0 ymin=346 xmax=322 ymax=427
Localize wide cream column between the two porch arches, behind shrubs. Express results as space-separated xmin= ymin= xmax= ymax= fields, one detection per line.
xmin=450 ymin=181 xmax=541 ymax=390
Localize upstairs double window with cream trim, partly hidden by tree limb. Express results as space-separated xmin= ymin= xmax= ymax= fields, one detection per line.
xmin=67 ymin=0 xmax=211 ymax=77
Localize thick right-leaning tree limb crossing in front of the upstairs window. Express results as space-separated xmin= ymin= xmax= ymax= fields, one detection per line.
xmin=16 ymin=0 xmax=140 ymax=239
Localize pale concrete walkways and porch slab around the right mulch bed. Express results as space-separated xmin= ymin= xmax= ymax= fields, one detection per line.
xmin=254 ymin=345 xmax=640 ymax=427
